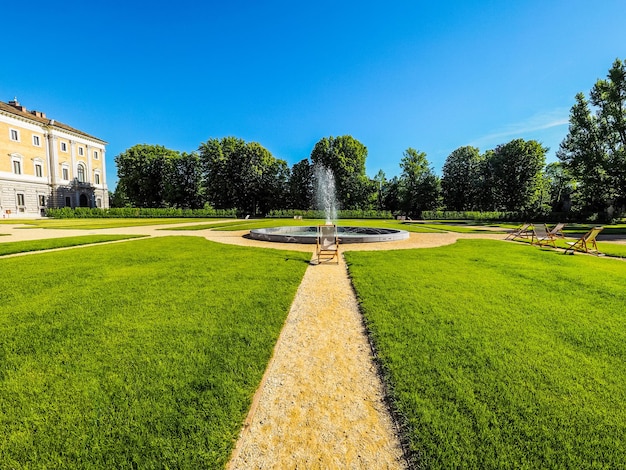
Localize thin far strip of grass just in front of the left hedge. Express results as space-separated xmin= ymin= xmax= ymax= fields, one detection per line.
xmin=4 ymin=218 xmax=223 ymax=230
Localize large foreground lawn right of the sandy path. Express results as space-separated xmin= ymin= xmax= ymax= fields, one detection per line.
xmin=345 ymin=240 xmax=626 ymax=469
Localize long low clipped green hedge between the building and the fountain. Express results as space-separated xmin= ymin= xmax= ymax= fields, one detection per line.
xmin=46 ymin=207 xmax=237 ymax=219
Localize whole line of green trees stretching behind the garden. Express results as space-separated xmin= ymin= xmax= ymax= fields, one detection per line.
xmin=112 ymin=59 xmax=626 ymax=217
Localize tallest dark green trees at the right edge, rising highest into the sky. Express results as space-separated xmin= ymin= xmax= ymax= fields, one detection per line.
xmin=557 ymin=59 xmax=626 ymax=211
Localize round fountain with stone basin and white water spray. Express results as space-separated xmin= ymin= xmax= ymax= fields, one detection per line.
xmin=250 ymin=165 xmax=409 ymax=244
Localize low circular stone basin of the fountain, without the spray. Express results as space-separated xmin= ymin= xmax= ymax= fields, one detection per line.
xmin=250 ymin=225 xmax=409 ymax=244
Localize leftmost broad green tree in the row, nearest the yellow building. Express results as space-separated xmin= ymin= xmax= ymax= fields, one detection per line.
xmin=115 ymin=144 xmax=179 ymax=207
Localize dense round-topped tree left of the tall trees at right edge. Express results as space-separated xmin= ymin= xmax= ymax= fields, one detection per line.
xmin=486 ymin=139 xmax=548 ymax=211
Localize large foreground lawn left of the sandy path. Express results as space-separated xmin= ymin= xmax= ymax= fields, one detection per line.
xmin=0 ymin=237 xmax=310 ymax=469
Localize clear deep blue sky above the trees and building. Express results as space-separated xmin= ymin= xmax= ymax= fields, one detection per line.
xmin=0 ymin=0 xmax=626 ymax=189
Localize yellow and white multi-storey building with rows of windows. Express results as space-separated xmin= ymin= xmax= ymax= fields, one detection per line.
xmin=0 ymin=99 xmax=109 ymax=218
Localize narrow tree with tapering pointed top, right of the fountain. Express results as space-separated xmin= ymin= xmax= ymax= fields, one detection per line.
xmin=400 ymin=147 xmax=440 ymax=218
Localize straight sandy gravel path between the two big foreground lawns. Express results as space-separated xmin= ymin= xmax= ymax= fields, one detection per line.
xmin=229 ymin=248 xmax=406 ymax=469
